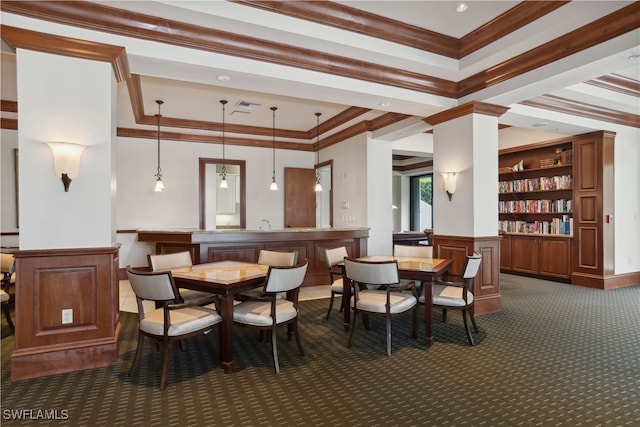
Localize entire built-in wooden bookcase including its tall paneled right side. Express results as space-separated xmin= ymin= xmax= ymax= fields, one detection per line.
xmin=498 ymin=131 xmax=619 ymax=289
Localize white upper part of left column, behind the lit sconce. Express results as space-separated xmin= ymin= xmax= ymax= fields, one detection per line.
xmin=17 ymin=49 xmax=116 ymax=250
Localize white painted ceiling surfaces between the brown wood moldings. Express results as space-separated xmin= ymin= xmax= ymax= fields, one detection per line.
xmin=2 ymin=0 xmax=640 ymax=151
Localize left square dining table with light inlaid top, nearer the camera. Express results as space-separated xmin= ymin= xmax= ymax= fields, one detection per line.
xmin=171 ymin=261 xmax=269 ymax=374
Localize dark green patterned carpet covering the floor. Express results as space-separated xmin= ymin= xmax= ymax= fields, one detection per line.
xmin=0 ymin=275 xmax=640 ymax=427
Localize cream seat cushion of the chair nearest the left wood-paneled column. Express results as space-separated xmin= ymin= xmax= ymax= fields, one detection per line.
xmin=140 ymin=304 xmax=222 ymax=337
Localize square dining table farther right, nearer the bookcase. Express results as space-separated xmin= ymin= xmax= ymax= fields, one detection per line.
xmin=343 ymin=255 xmax=454 ymax=347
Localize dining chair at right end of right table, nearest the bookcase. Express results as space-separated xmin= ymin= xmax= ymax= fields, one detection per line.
xmin=418 ymin=253 xmax=482 ymax=345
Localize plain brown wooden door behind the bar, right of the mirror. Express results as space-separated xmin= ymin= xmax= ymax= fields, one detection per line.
xmin=284 ymin=168 xmax=316 ymax=227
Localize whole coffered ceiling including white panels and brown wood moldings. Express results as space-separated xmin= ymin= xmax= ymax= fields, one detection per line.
xmin=0 ymin=0 xmax=640 ymax=158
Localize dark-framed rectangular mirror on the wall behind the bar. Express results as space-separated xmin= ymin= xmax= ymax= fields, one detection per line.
xmin=199 ymin=157 xmax=247 ymax=230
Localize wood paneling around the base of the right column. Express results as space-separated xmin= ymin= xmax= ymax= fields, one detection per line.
xmin=431 ymin=234 xmax=502 ymax=314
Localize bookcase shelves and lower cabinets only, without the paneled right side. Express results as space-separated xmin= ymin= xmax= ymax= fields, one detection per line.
xmin=498 ymin=141 xmax=574 ymax=281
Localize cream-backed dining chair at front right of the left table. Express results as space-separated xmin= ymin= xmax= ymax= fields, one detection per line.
xmin=233 ymin=259 xmax=308 ymax=374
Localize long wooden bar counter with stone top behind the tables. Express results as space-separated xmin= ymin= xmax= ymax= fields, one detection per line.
xmin=137 ymin=227 xmax=369 ymax=286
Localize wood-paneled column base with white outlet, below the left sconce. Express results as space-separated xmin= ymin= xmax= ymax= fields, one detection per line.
xmin=11 ymin=245 xmax=120 ymax=381
